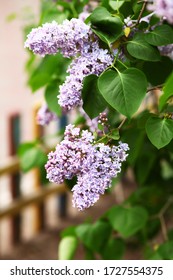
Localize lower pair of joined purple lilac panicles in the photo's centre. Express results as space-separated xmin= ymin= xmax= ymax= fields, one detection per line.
xmin=45 ymin=125 xmax=129 ymax=210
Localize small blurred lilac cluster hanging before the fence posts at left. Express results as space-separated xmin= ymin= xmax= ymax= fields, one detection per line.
xmin=36 ymin=104 xmax=58 ymax=125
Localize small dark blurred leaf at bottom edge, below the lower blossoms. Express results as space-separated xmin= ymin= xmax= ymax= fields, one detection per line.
xmin=101 ymin=238 xmax=125 ymax=260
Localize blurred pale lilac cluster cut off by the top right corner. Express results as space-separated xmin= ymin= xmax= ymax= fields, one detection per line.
xmin=148 ymin=0 xmax=173 ymax=24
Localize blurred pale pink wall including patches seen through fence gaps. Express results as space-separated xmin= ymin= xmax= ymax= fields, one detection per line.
xmin=0 ymin=0 xmax=41 ymax=253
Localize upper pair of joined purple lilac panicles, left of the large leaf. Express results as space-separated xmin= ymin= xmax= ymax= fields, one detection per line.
xmin=25 ymin=18 xmax=113 ymax=112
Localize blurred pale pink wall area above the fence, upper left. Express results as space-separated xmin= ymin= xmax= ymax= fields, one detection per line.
xmin=0 ymin=0 xmax=40 ymax=161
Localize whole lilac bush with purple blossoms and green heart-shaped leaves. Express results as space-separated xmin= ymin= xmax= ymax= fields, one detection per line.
xmin=21 ymin=0 xmax=173 ymax=260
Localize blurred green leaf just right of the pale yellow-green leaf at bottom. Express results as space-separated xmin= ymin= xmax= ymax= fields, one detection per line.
xmin=76 ymin=220 xmax=112 ymax=252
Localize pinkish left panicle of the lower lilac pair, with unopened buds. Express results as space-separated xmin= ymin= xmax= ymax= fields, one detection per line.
xmin=45 ymin=125 xmax=93 ymax=184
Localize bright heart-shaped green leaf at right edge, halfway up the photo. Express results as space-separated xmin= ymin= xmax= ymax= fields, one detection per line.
xmin=146 ymin=117 xmax=173 ymax=149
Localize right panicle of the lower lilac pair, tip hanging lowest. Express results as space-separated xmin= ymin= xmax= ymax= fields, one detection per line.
xmin=72 ymin=143 xmax=128 ymax=210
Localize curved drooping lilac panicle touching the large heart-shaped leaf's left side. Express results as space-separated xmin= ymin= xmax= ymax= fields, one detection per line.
xmin=58 ymin=41 xmax=113 ymax=111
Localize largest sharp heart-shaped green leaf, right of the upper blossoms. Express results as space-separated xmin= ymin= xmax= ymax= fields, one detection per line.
xmin=98 ymin=68 xmax=147 ymax=118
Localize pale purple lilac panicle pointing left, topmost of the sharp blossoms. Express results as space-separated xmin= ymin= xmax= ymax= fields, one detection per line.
xmin=25 ymin=18 xmax=91 ymax=57
